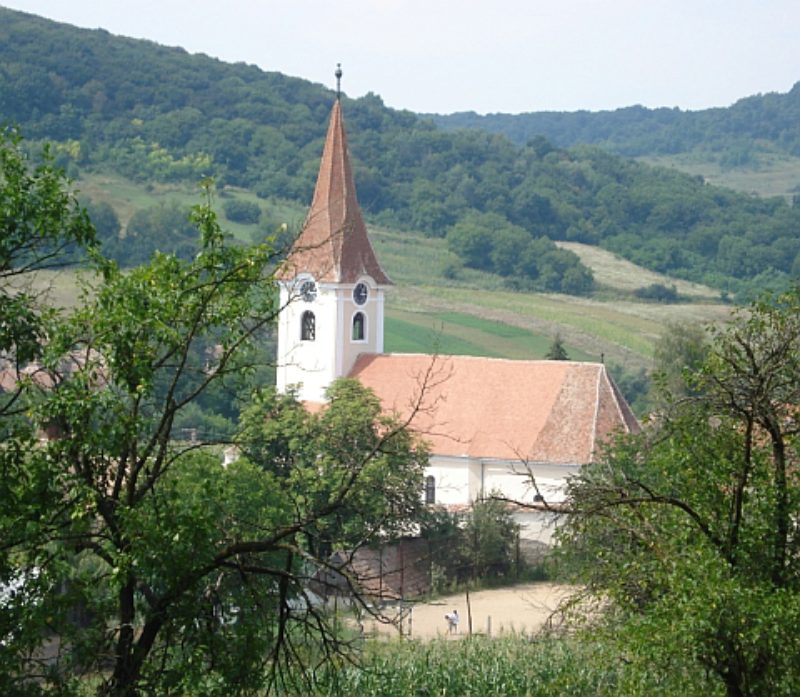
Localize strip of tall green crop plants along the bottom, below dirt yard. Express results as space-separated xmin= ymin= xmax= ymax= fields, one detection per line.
xmin=314 ymin=635 xmax=719 ymax=697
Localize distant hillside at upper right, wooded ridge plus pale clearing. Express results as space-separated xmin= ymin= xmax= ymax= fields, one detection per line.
xmin=430 ymin=82 xmax=800 ymax=201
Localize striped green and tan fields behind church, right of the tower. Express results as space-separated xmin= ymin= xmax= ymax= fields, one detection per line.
xmin=372 ymin=229 xmax=730 ymax=368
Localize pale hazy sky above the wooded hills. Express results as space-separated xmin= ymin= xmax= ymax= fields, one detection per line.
xmin=0 ymin=0 xmax=800 ymax=113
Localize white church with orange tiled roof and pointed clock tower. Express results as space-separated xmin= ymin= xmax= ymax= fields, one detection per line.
xmin=277 ymin=84 xmax=639 ymax=538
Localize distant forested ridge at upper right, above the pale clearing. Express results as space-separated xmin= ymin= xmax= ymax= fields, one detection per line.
xmin=431 ymin=82 xmax=800 ymax=158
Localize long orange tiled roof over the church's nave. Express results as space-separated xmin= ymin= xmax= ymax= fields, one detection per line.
xmin=350 ymin=354 xmax=640 ymax=464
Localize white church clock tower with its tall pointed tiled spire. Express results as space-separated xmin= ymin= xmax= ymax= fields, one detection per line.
xmin=277 ymin=70 xmax=391 ymax=402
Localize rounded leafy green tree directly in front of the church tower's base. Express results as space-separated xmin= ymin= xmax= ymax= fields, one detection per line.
xmin=240 ymin=379 xmax=428 ymax=558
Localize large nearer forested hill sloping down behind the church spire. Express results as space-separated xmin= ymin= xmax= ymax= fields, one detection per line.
xmin=0 ymin=8 xmax=800 ymax=293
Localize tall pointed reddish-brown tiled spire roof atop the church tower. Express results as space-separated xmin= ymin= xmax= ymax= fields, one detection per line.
xmin=278 ymin=99 xmax=391 ymax=285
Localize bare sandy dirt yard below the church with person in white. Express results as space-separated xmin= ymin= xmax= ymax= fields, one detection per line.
xmin=366 ymin=583 xmax=572 ymax=639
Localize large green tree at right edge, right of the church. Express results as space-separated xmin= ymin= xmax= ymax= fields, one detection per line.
xmin=561 ymin=288 xmax=800 ymax=697
